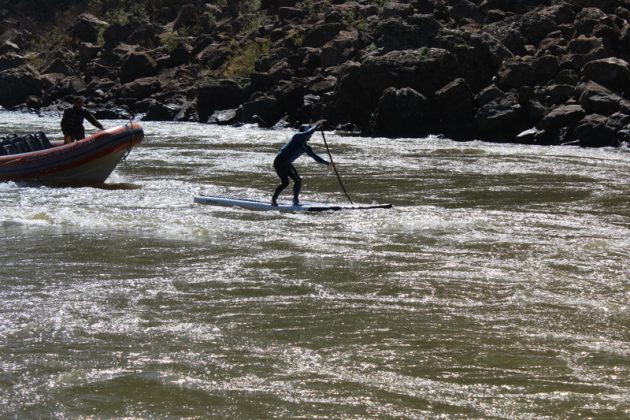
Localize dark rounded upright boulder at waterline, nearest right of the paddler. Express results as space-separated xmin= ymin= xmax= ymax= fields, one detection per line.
xmin=370 ymin=87 xmax=429 ymax=137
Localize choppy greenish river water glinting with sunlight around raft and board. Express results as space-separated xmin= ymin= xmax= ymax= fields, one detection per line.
xmin=0 ymin=112 xmax=630 ymax=418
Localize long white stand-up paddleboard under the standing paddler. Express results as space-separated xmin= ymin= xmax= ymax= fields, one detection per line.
xmin=195 ymin=195 xmax=392 ymax=212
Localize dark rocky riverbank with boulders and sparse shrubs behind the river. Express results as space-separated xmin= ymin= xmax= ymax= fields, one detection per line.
xmin=0 ymin=0 xmax=630 ymax=147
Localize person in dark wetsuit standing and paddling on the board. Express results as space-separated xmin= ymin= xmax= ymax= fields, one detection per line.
xmin=271 ymin=120 xmax=334 ymax=206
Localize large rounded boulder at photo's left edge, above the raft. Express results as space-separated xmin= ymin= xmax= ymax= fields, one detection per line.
xmin=0 ymin=66 xmax=44 ymax=107
